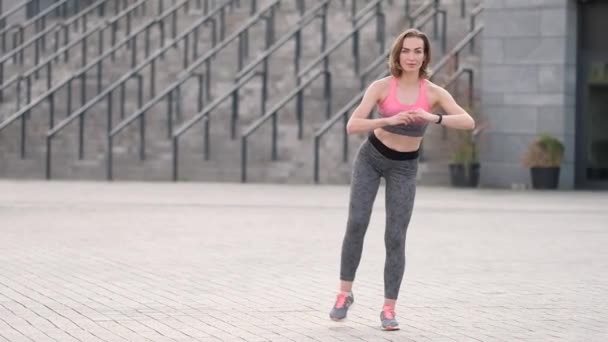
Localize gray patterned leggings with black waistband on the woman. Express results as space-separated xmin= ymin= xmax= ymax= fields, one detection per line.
xmin=340 ymin=134 xmax=418 ymax=299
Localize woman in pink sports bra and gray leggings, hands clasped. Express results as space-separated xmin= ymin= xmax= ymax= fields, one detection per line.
xmin=330 ymin=29 xmax=475 ymax=330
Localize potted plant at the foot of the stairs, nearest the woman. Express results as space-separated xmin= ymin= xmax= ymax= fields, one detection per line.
xmin=449 ymin=129 xmax=480 ymax=188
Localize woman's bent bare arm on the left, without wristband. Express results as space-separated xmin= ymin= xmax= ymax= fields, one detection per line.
xmin=346 ymin=81 xmax=415 ymax=134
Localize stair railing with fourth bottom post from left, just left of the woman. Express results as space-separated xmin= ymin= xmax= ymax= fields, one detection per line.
xmin=241 ymin=0 xmax=385 ymax=182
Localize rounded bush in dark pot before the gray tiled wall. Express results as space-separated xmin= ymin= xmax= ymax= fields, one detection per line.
xmin=523 ymin=134 xmax=564 ymax=189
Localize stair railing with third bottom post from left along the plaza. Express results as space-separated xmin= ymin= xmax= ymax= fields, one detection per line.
xmin=173 ymin=0 xmax=329 ymax=181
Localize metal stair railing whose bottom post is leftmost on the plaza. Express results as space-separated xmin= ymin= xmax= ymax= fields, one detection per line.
xmin=42 ymin=0 xmax=252 ymax=179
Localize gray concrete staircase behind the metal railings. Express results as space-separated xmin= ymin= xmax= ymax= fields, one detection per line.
xmin=0 ymin=0 xmax=484 ymax=183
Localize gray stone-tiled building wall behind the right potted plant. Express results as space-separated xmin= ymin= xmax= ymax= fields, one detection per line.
xmin=480 ymin=0 xmax=577 ymax=188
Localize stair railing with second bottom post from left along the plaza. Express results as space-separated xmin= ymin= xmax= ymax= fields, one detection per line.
xmin=106 ymin=0 xmax=281 ymax=179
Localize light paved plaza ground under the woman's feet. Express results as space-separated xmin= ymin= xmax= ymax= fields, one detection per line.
xmin=0 ymin=181 xmax=608 ymax=342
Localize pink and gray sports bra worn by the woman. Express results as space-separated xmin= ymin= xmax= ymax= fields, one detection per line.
xmin=378 ymin=77 xmax=431 ymax=137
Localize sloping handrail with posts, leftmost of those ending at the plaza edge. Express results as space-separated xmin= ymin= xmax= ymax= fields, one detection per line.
xmin=42 ymin=0 xmax=252 ymax=178
